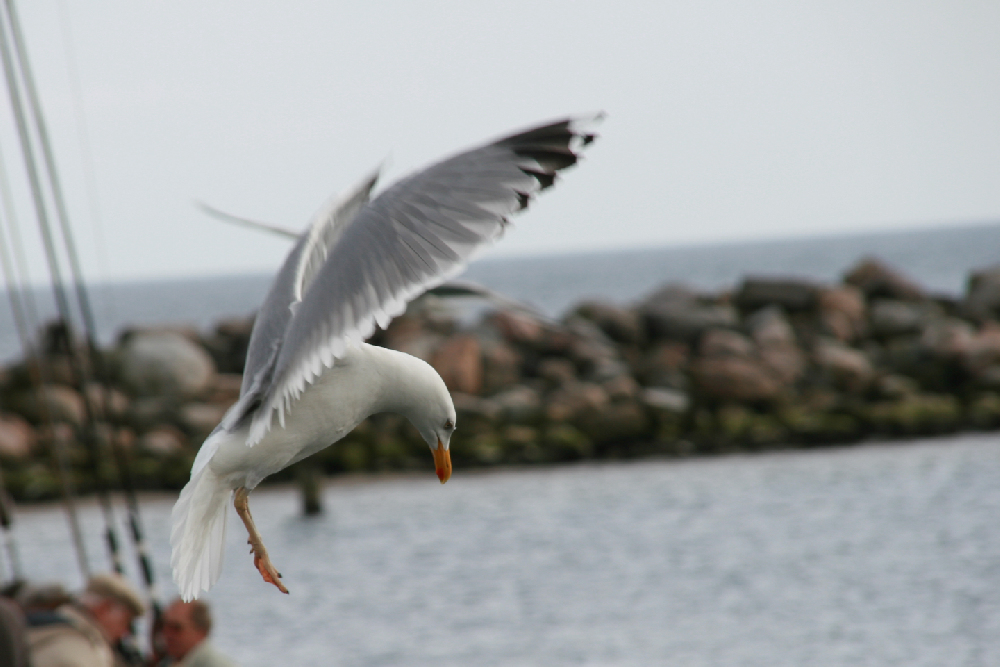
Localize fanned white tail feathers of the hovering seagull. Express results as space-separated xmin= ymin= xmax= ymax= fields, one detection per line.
xmin=170 ymin=465 xmax=232 ymax=602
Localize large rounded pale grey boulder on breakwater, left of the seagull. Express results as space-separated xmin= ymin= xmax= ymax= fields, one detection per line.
xmin=117 ymin=331 xmax=215 ymax=398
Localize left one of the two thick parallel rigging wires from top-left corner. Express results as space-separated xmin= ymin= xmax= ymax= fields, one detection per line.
xmin=0 ymin=0 xmax=123 ymax=572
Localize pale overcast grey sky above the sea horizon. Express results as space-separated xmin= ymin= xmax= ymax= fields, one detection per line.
xmin=0 ymin=0 xmax=1000 ymax=280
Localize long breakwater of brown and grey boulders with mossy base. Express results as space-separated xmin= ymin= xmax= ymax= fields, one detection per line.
xmin=0 ymin=260 xmax=1000 ymax=499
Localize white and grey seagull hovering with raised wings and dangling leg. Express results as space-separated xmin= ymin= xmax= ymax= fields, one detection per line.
xmin=170 ymin=114 xmax=603 ymax=601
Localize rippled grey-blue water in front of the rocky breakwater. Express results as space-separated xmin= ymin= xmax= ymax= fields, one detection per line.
xmin=17 ymin=436 xmax=1000 ymax=667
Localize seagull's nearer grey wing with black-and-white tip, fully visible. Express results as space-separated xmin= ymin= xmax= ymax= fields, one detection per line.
xmin=247 ymin=116 xmax=600 ymax=445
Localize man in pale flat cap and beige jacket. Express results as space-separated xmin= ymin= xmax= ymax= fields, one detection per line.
xmin=28 ymin=574 xmax=145 ymax=667
